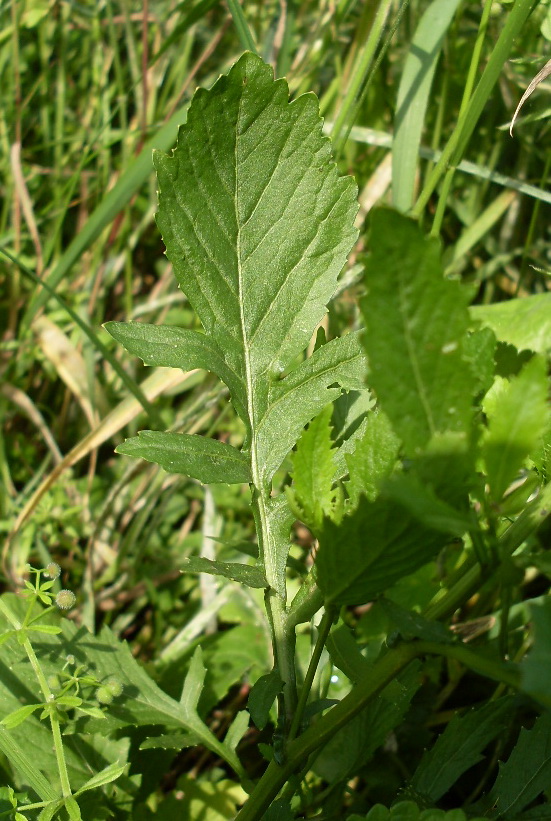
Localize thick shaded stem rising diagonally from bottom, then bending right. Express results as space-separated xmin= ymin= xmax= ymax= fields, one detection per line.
xmin=235 ymin=641 xmax=520 ymax=821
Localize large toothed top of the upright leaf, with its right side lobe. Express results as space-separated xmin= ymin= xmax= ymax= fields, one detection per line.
xmin=155 ymin=54 xmax=363 ymax=486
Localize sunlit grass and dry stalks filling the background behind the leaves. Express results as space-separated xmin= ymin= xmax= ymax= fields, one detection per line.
xmin=0 ymin=0 xmax=551 ymax=821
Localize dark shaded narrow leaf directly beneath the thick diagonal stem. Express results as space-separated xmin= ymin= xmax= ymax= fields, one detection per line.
xmin=313 ymin=661 xmax=421 ymax=784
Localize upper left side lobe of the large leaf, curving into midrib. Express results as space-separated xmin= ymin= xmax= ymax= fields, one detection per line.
xmin=103 ymin=322 xmax=247 ymax=420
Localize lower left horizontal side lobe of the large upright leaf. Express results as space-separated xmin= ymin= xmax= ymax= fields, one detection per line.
xmin=117 ymin=430 xmax=251 ymax=484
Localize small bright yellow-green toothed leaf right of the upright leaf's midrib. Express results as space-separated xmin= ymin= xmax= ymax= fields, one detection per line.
xmin=287 ymin=405 xmax=340 ymax=533
